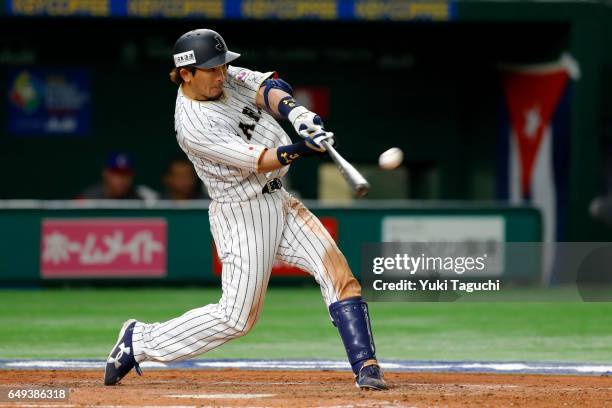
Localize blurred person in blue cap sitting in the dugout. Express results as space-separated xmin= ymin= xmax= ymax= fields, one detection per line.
xmin=78 ymin=152 xmax=158 ymax=201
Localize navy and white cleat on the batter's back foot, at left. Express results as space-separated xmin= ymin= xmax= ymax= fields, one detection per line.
xmin=104 ymin=319 xmax=142 ymax=385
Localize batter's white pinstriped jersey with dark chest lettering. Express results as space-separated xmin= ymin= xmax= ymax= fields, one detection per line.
xmin=174 ymin=66 xmax=291 ymax=202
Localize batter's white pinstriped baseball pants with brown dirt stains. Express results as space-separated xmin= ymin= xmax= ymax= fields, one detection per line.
xmin=132 ymin=190 xmax=361 ymax=362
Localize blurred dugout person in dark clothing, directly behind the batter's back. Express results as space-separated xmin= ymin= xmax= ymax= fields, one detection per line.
xmin=160 ymin=157 xmax=209 ymax=201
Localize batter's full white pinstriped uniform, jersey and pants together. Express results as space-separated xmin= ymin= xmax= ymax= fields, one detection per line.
xmin=133 ymin=66 xmax=360 ymax=362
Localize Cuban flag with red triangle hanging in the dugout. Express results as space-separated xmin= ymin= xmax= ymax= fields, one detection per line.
xmin=498 ymin=54 xmax=580 ymax=284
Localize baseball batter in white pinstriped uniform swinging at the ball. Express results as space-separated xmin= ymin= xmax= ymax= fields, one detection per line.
xmin=104 ymin=29 xmax=387 ymax=390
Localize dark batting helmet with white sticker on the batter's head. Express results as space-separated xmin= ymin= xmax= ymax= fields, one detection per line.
xmin=172 ymin=29 xmax=240 ymax=68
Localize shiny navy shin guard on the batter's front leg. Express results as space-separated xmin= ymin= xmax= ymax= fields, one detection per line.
xmin=329 ymin=296 xmax=376 ymax=375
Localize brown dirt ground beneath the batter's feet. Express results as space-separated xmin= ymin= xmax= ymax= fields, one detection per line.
xmin=0 ymin=369 xmax=612 ymax=408
